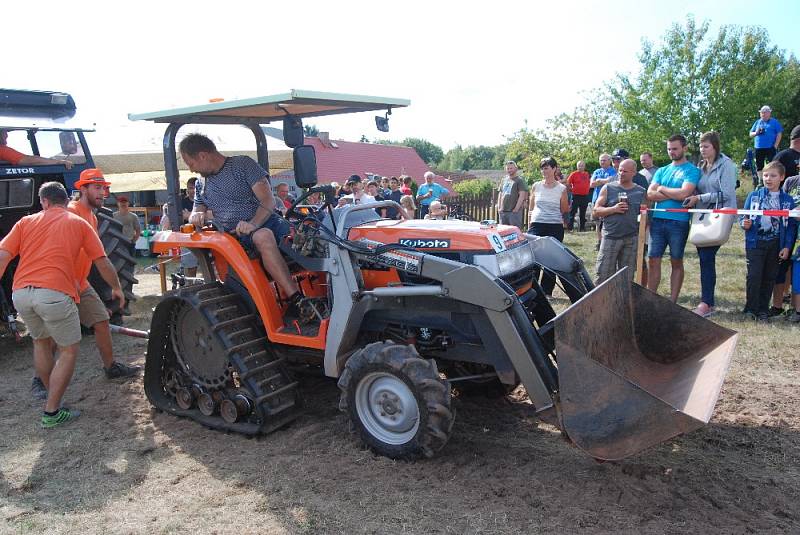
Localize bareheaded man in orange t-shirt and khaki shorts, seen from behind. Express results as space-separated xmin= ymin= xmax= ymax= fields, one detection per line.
xmin=0 ymin=182 xmax=125 ymax=428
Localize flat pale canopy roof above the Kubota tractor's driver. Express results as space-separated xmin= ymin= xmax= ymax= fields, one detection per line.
xmin=128 ymin=89 xmax=411 ymax=124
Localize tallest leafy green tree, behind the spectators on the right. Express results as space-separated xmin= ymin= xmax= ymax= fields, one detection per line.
xmin=607 ymin=17 xmax=800 ymax=161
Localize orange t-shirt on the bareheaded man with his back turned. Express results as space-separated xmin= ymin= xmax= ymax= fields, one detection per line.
xmin=0 ymin=207 xmax=105 ymax=303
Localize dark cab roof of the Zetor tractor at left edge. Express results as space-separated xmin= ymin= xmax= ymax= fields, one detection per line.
xmin=0 ymin=89 xmax=94 ymax=132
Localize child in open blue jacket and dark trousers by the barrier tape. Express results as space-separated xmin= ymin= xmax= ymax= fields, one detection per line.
xmin=740 ymin=162 xmax=797 ymax=321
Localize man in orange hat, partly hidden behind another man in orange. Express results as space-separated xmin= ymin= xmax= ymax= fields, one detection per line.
xmin=31 ymin=169 xmax=142 ymax=399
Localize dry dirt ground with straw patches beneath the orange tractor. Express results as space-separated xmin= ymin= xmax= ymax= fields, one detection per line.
xmin=0 ymin=252 xmax=800 ymax=534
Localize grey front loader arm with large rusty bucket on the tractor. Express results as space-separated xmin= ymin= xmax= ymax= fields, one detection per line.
xmin=326 ymin=232 xmax=737 ymax=460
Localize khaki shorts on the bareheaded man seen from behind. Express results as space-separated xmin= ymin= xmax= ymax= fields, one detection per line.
xmin=11 ymin=286 xmax=81 ymax=347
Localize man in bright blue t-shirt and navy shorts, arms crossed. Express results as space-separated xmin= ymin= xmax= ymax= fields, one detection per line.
xmin=647 ymin=134 xmax=700 ymax=303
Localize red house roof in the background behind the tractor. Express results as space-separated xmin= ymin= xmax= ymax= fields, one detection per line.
xmin=305 ymin=137 xmax=434 ymax=189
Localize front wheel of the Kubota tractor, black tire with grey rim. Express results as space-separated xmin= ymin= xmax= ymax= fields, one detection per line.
xmin=339 ymin=341 xmax=455 ymax=460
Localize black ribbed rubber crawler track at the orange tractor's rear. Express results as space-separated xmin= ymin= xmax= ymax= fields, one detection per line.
xmin=147 ymin=283 xmax=302 ymax=434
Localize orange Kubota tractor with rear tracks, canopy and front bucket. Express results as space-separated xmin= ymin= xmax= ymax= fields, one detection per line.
xmin=130 ymin=91 xmax=736 ymax=459
